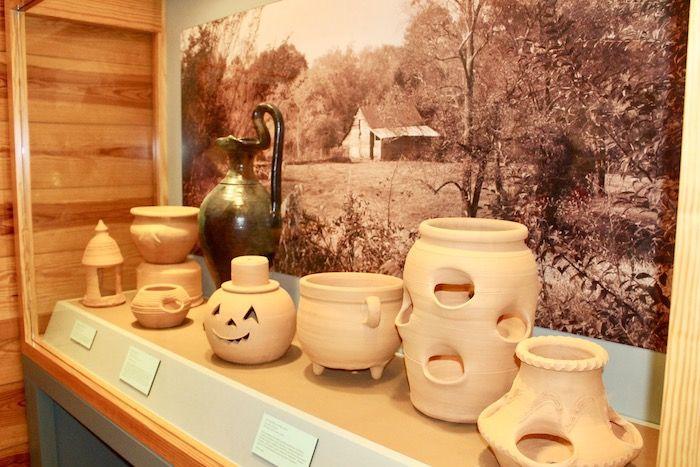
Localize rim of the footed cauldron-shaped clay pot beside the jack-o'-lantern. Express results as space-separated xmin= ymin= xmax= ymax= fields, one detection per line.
xmin=299 ymin=272 xmax=403 ymax=302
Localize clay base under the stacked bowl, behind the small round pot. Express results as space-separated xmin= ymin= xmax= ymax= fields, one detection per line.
xmin=136 ymin=259 xmax=204 ymax=307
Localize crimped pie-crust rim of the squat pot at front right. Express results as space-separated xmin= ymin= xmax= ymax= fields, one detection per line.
xmin=515 ymin=336 xmax=608 ymax=371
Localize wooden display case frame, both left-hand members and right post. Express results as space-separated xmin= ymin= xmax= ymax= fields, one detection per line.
xmin=5 ymin=0 xmax=700 ymax=467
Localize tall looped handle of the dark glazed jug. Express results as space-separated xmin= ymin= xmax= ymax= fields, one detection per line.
xmin=253 ymin=103 xmax=284 ymax=227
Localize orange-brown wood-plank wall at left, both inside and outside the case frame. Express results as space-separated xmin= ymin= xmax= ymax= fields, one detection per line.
xmin=0 ymin=0 xmax=164 ymax=465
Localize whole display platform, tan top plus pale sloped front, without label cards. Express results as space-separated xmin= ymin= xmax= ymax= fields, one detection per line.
xmin=44 ymin=301 xmax=658 ymax=466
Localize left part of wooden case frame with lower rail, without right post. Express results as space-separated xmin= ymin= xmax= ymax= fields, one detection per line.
xmin=5 ymin=0 xmax=219 ymax=466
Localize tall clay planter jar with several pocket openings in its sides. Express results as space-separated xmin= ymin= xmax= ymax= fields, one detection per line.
xmin=396 ymin=218 xmax=540 ymax=423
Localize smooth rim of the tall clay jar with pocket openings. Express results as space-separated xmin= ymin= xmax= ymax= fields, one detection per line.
xmin=418 ymin=217 xmax=527 ymax=243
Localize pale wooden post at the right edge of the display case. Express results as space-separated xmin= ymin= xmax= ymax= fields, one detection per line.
xmin=657 ymin=0 xmax=700 ymax=467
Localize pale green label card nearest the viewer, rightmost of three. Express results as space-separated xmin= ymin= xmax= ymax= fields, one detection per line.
xmin=253 ymin=414 xmax=318 ymax=467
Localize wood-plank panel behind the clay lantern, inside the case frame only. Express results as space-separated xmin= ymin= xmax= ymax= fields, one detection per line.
xmin=26 ymin=12 xmax=156 ymax=329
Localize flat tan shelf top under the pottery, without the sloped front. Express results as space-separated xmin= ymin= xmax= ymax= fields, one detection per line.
xmin=46 ymin=301 xmax=658 ymax=467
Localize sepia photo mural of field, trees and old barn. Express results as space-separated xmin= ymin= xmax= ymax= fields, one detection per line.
xmin=181 ymin=0 xmax=688 ymax=351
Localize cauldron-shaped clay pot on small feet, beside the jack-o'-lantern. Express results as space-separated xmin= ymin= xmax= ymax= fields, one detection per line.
xmin=297 ymin=272 xmax=403 ymax=379
